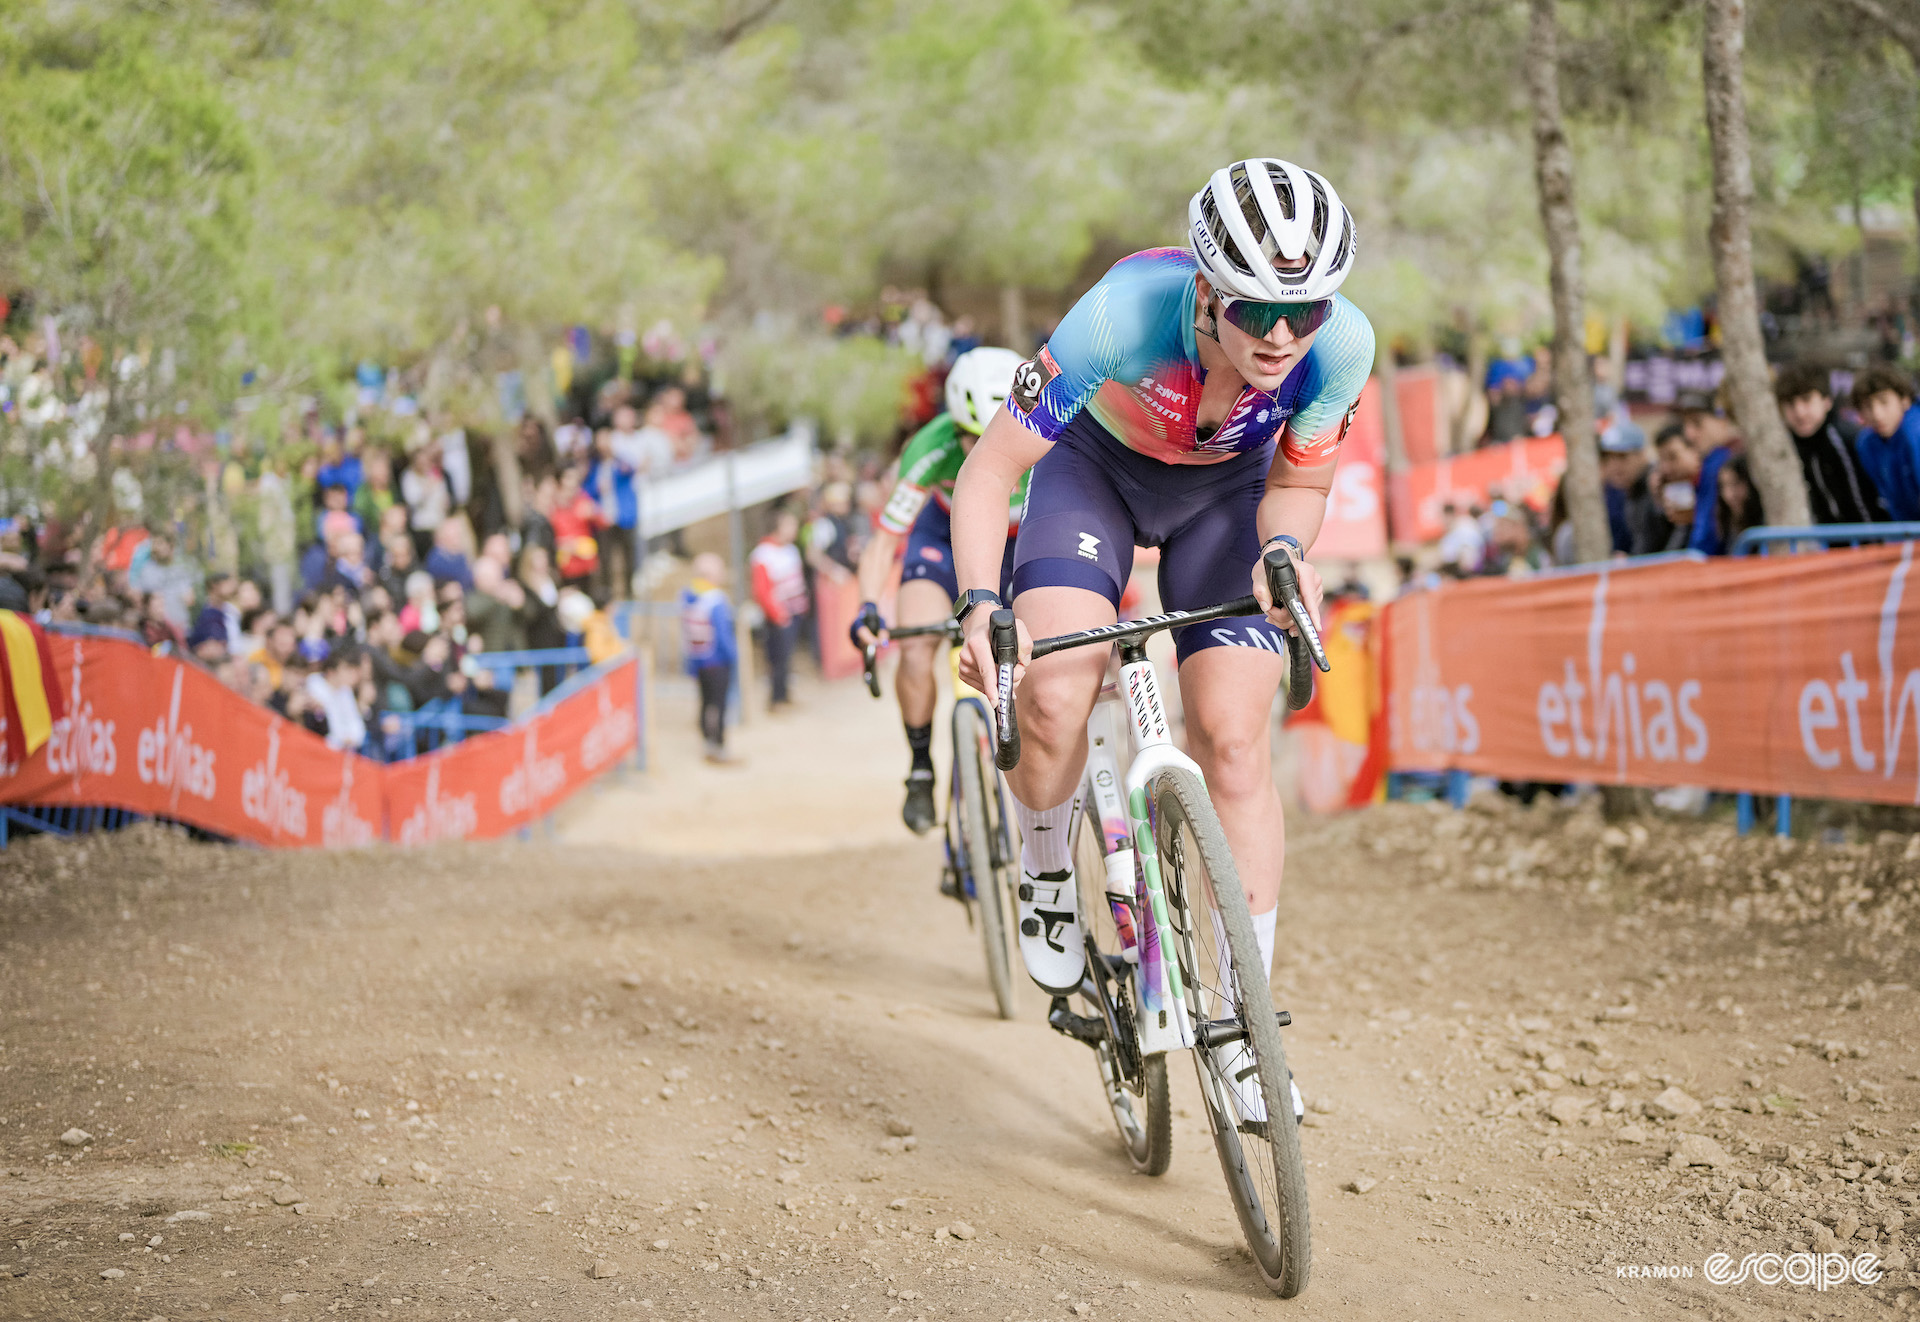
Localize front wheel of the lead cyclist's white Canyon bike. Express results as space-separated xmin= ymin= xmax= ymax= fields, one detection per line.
xmin=1148 ymin=767 xmax=1313 ymax=1299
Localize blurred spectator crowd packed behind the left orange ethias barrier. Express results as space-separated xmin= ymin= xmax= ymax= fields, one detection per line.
xmin=0 ymin=326 xmax=724 ymax=758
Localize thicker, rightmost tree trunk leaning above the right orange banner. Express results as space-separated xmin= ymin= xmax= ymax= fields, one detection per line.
xmin=1701 ymin=0 xmax=1812 ymax=526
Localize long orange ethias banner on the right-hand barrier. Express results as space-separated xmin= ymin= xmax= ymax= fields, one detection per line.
xmin=1384 ymin=543 xmax=1920 ymax=804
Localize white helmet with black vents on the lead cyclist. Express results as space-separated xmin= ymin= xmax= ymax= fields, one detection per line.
xmin=1187 ymin=157 xmax=1359 ymax=303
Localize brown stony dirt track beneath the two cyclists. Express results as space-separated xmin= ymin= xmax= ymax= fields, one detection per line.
xmin=0 ymin=671 xmax=1920 ymax=1322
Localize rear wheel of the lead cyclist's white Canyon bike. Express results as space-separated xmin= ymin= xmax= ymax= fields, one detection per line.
xmin=1073 ymin=804 xmax=1173 ymax=1174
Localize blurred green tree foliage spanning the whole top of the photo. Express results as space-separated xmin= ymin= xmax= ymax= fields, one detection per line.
xmin=0 ymin=0 xmax=1920 ymax=521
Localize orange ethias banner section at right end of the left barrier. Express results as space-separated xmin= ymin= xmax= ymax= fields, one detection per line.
xmin=384 ymin=658 xmax=639 ymax=844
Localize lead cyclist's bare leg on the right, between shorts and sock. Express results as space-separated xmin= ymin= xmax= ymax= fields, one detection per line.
xmin=1181 ymin=647 xmax=1286 ymax=915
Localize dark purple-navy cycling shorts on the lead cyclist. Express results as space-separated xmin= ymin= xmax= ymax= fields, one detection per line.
xmin=1014 ymin=413 xmax=1286 ymax=660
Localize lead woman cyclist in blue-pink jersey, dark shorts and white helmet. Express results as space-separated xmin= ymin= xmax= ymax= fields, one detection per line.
xmin=952 ymin=159 xmax=1373 ymax=1119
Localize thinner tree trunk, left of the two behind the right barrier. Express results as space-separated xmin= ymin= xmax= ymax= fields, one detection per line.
xmin=1526 ymin=0 xmax=1613 ymax=564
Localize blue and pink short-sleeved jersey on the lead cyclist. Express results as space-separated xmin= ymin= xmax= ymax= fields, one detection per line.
xmin=1006 ymin=248 xmax=1373 ymax=464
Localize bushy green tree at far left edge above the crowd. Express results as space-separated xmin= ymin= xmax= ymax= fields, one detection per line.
xmin=0 ymin=6 xmax=261 ymax=533
